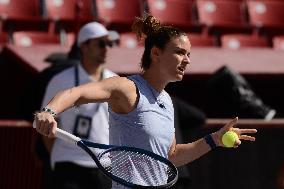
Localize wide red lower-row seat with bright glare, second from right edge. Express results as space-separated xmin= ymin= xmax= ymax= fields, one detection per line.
xmin=221 ymin=34 xmax=269 ymax=49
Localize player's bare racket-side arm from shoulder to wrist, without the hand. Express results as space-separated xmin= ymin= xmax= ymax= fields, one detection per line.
xmin=47 ymin=77 xmax=135 ymax=113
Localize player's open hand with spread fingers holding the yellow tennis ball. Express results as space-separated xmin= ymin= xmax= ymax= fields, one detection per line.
xmin=212 ymin=117 xmax=257 ymax=148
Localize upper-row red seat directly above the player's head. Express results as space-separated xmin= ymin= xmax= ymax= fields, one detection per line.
xmin=148 ymin=0 xmax=201 ymax=31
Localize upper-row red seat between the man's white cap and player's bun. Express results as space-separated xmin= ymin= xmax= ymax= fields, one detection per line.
xmin=96 ymin=0 xmax=142 ymax=32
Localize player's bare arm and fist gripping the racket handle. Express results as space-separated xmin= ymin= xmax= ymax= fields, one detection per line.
xmin=35 ymin=77 xmax=137 ymax=137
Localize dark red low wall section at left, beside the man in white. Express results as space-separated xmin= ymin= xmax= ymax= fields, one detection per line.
xmin=0 ymin=120 xmax=42 ymax=189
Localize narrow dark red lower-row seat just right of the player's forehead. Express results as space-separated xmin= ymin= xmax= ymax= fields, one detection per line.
xmin=188 ymin=33 xmax=217 ymax=48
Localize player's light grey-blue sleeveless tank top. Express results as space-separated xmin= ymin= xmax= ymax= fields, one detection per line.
xmin=109 ymin=75 xmax=175 ymax=189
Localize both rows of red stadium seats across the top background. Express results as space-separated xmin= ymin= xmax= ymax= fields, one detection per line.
xmin=0 ymin=0 xmax=284 ymax=49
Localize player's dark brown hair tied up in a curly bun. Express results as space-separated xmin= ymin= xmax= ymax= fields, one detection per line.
xmin=132 ymin=14 xmax=186 ymax=70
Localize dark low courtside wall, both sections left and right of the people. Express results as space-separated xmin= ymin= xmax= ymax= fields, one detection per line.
xmin=0 ymin=119 xmax=284 ymax=189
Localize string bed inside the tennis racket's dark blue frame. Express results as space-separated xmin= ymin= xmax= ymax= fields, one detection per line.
xmin=100 ymin=151 xmax=176 ymax=186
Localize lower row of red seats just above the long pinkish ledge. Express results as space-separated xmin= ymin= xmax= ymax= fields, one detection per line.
xmin=0 ymin=31 xmax=284 ymax=50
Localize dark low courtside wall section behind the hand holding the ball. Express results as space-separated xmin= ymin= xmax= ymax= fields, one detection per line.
xmin=183 ymin=119 xmax=284 ymax=189
